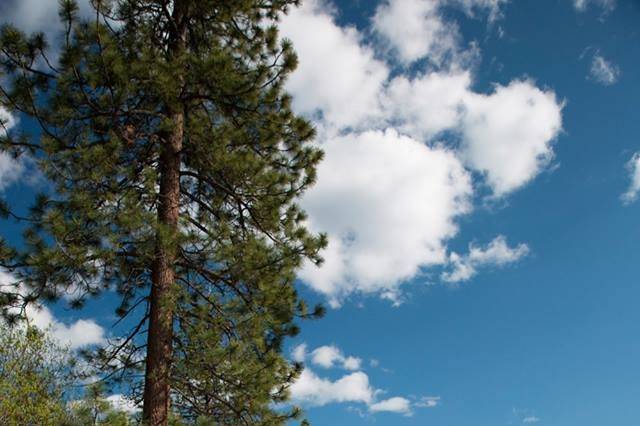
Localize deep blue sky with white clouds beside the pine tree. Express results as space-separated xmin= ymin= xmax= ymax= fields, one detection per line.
xmin=0 ymin=0 xmax=640 ymax=426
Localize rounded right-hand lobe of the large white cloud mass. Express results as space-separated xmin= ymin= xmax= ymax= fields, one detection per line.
xmin=461 ymin=80 xmax=562 ymax=197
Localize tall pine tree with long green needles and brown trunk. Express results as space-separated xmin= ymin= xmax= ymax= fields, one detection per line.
xmin=0 ymin=0 xmax=325 ymax=426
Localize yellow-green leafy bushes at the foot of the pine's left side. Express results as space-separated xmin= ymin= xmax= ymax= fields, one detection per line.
xmin=0 ymin=324 xmax=134 ymax=426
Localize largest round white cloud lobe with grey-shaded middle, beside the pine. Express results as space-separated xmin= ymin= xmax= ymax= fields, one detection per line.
xmin=300 ymin=129 xmax=472 ymax=302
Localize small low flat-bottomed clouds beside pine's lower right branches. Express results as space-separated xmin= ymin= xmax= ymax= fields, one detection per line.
xmin=291 ymin=344 xmax=440 ymax=416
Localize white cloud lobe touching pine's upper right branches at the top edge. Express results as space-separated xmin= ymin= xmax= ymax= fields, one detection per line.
xmin=280 ymin=0 xmax=389 ymax=127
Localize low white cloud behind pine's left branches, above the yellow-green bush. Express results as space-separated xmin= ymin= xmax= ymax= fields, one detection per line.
xmin=0 ymin=271 xmax=105 ymax=349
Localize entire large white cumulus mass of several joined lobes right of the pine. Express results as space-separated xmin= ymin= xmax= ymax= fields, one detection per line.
xmin=282 ymin=0 xmax=562 ymax=305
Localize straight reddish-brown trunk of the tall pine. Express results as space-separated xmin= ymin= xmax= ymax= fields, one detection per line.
xmin=142 ymin=0 xmax=186 ymax=426
